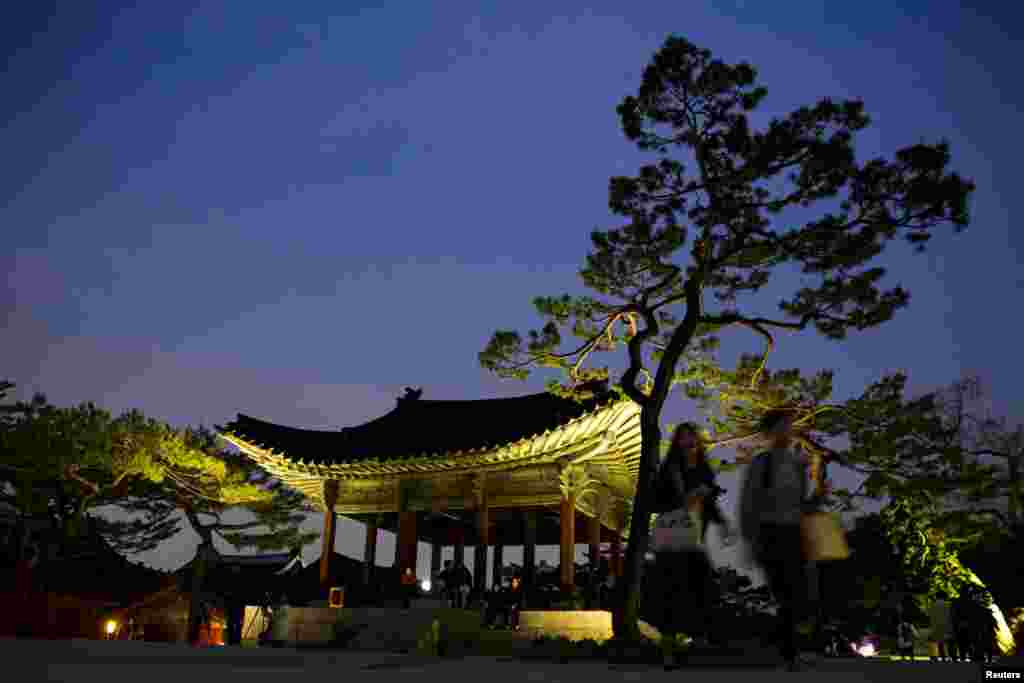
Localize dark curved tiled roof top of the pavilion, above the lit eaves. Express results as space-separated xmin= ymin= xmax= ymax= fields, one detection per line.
xmin=220 ymin=392 xmax=610 ymax=465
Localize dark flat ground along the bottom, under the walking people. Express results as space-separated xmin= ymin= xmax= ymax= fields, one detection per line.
xmin=6 ymin=639 xmax=1020 ymax=683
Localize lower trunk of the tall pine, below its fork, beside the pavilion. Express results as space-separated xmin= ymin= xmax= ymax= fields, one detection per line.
xmin=611 ymin=405 xmax=662 ymax=641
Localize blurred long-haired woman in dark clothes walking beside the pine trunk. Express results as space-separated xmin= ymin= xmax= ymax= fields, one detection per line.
xmin=655 ymin=423 xmax=732 ymax=670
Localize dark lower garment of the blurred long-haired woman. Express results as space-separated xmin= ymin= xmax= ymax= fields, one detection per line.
xmin=652 ymin=549 xmax=715 ymax=637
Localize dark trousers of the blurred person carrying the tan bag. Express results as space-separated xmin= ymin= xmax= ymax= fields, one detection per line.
xmin=755 ymin=524 xmax=807 ymax=660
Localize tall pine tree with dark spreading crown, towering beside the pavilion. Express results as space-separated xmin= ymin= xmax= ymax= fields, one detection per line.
xmin=479 ymin=37 xmax=974 ymax=638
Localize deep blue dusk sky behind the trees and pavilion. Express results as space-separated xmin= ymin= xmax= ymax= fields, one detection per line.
xmin=0 ymin=0 xmax=1024 ymax=572
